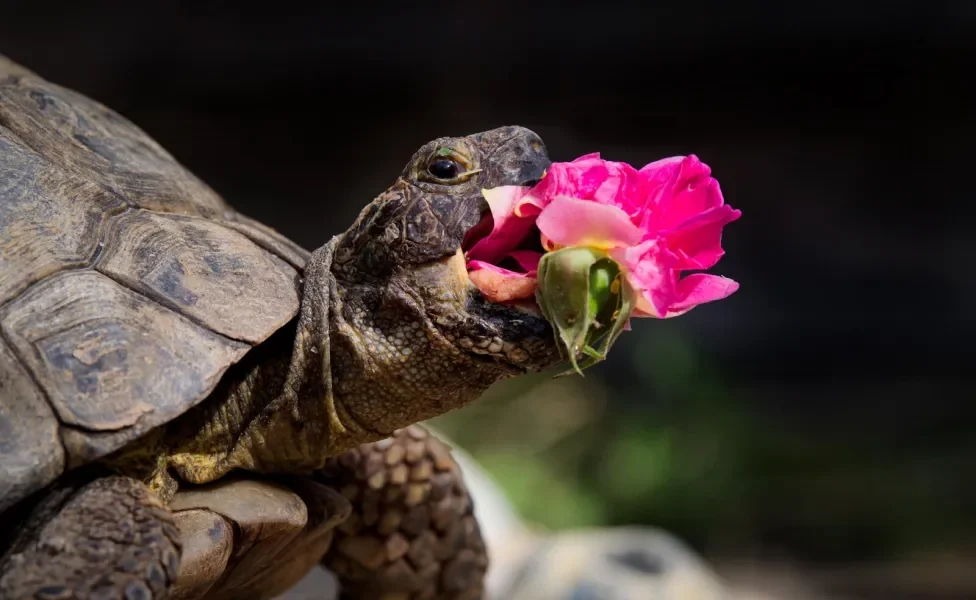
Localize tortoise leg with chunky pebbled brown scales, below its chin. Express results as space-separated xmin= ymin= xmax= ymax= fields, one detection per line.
xmin=322 ymin=425 xmax=488 ymax=600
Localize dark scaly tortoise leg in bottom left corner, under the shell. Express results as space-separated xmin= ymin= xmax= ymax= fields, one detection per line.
xmin=0 ymin=476 xmax=180 ymax=600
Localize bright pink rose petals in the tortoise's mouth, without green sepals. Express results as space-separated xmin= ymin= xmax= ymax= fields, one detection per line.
xmin=466 ymin=153 xmax=742 ymax=318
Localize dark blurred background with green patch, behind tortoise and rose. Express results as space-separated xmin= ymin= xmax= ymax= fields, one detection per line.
xmin=0 ymin=0 xmax=976 ymax=599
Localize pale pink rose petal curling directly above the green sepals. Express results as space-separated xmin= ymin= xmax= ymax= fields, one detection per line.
xmin=536 ymin=196 xmax=642 ymax=249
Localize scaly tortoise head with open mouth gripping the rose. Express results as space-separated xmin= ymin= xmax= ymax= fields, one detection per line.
xmin=332 ymin=127 xmax=558 ymax=433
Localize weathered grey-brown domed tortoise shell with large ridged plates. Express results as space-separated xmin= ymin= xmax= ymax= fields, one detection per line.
xmin=0 ymin=55 xmax=309 ymax=511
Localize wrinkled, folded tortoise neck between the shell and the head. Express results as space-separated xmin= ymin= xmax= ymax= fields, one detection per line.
xmin=167 ymin=240 xmax=350 ymax=483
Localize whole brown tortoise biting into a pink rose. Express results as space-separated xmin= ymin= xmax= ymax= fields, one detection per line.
xmin=0 ymin=56 xmax=559 ymax=600
